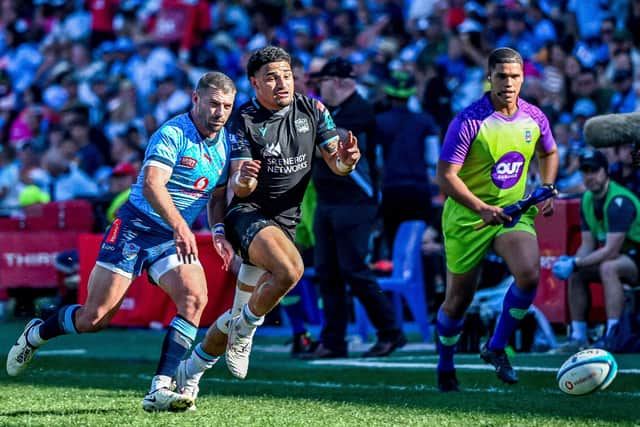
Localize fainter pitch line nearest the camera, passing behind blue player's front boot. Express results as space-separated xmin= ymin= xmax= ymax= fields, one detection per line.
xmin=40 ymin=369 xmax=640 ymax=398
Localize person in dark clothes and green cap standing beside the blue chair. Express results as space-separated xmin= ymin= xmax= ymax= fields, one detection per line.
xmin=375 ymin=72 xmax=440 ymax=248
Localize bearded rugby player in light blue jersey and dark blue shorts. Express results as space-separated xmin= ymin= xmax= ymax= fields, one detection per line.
xmin=7 ymin=72 xmax=236 ymax=411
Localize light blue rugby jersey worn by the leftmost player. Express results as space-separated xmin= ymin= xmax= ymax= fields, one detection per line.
xmin=129 ymin=113 xmax=231 ymax=229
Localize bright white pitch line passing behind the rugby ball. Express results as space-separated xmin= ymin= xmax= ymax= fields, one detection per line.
xmin=309 ymin=359 xmax=640 ymax=375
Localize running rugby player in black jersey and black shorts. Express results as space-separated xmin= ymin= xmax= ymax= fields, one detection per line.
xmin=177 ymin=46 xmax=360 ymax=394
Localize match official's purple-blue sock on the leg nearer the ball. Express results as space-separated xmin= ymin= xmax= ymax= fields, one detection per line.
xmin=488 ymin=282 xmax=536 ymax=350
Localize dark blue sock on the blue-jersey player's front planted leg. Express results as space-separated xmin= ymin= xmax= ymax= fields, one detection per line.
xmin=156 ymin=315 xmax=198 ymax=377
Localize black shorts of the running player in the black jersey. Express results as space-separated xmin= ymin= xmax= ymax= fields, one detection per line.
xmin=224 ymin=202 xmax=300 ymax=262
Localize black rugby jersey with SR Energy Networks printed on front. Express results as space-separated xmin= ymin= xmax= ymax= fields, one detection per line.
xmin=227 ymin=94 xmax=338 ymax=215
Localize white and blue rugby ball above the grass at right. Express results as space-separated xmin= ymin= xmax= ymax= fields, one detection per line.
xmin=556 ymin=348 xmax=618 ymax=396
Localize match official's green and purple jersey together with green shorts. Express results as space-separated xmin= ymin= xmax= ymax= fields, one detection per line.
xmin=440 ymin=94 xmax=556 ymax=274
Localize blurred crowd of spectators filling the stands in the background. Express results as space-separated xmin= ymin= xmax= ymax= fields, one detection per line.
xmin=0 ymin=0 xmax=640 ymax=328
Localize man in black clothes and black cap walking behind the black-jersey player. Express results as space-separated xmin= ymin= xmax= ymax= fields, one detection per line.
xmin=303 ymin=58 xmax=407 ymax=359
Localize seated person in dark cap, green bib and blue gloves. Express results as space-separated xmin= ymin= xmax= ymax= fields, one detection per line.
xmin=552 ymin=150 xmax=640 ymax=353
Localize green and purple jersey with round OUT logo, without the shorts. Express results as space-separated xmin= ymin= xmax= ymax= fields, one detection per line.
xmin=440 ymin=93 xmax=555 ymax=206
